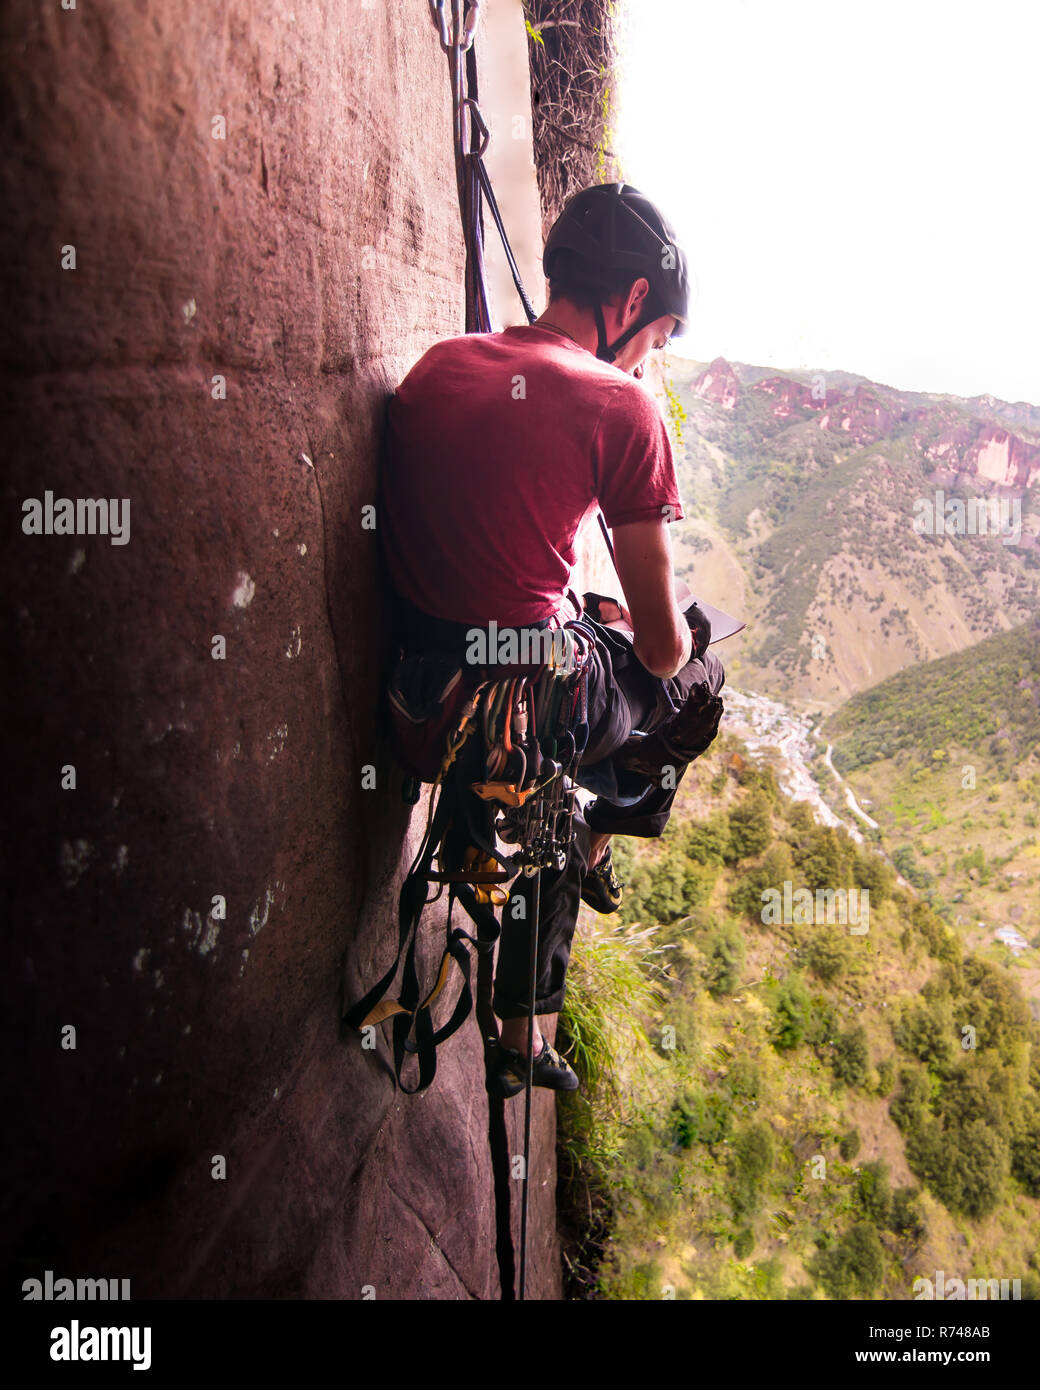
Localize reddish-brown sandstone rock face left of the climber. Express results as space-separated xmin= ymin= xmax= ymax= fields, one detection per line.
xmin=0 ymin=0 xmax=560 ymax=1298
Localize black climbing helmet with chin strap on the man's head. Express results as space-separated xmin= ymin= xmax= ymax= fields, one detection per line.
xmin=542 ymin=183 xmax=690 ymax=361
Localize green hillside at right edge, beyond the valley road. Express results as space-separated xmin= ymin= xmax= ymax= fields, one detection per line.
xmin=824 ymin=624 xmax=1040 ymax=973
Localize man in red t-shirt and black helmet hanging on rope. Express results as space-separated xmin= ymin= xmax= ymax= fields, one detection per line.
xmin=381 ymin=183 xmax=724 ymax=1095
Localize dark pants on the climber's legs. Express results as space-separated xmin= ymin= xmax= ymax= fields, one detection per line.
xmin=494 ymin=644 xmax=726 ymax=1019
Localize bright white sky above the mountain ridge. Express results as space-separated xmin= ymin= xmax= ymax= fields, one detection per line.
xmin=616 ymin=0 xmax=1040 ymax=404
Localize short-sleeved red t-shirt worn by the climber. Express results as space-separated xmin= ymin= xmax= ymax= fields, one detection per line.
xmin=378 ymin=319 xmax=683 ymax=626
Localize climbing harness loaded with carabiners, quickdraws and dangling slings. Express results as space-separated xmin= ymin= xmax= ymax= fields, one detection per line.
xmin=346 ymin=620 xmax=595 ymax=1300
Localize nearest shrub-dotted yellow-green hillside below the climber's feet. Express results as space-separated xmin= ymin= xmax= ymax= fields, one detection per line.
xmin=560 ymin=737 xmax=1040 ymax=1300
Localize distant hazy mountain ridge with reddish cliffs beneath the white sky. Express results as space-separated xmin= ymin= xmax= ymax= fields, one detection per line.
xmin=667 ymin=357 xmax=1040 ymax=710
